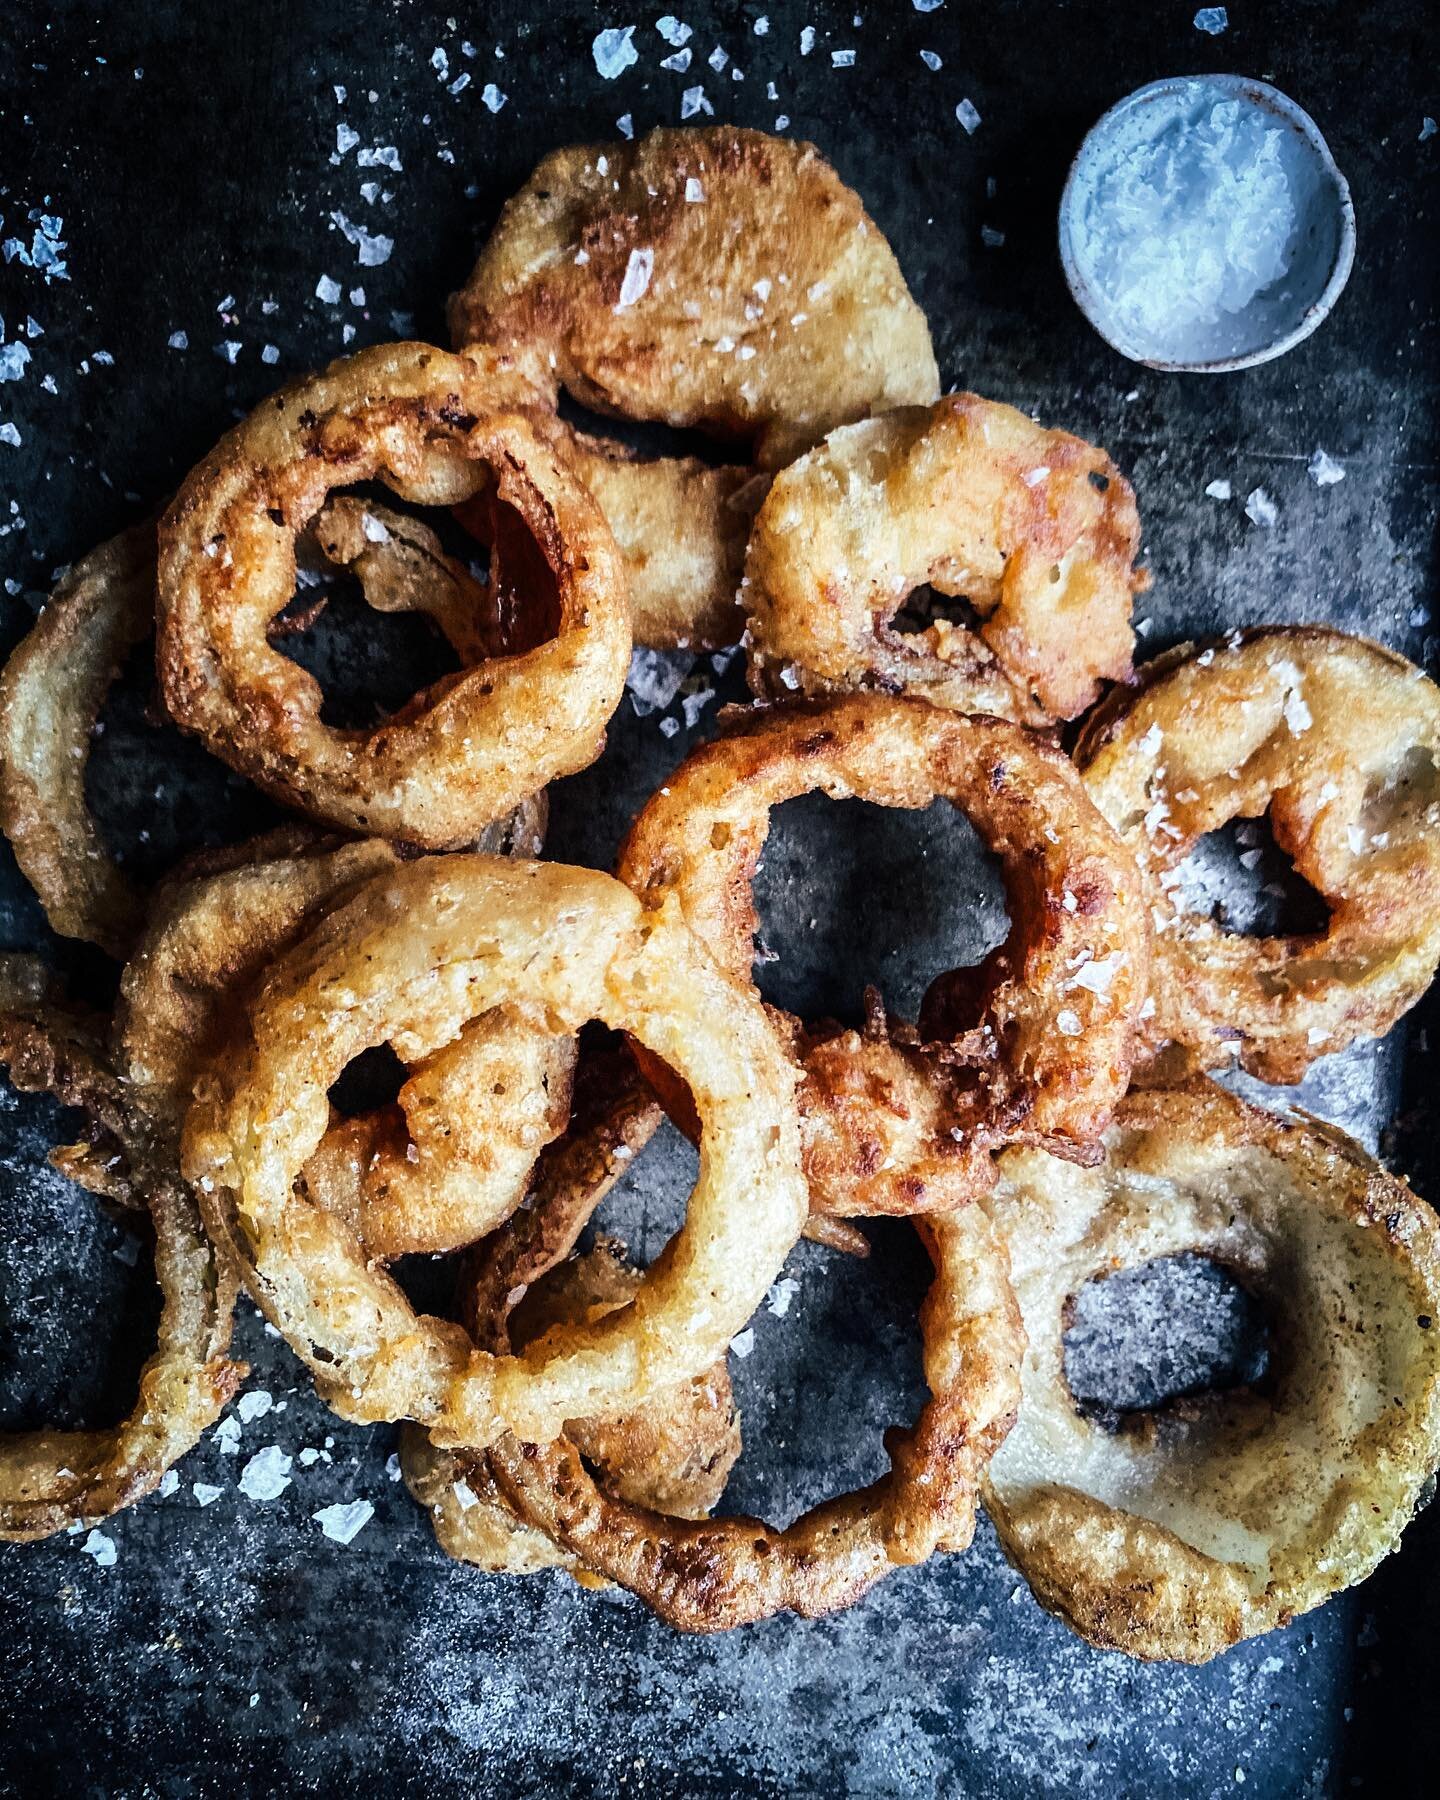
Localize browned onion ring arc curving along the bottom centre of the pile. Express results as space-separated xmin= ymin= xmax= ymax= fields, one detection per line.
xmin=490 ymin=1206 xmax=1024 ymax=1631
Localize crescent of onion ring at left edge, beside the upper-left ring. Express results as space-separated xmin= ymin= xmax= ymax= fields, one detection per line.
xmin=0 ymin=522 xmax=155 ymax=956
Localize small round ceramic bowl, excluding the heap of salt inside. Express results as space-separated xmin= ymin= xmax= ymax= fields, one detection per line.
xmin=1060 ymin=76 xmax=1355 ymax=374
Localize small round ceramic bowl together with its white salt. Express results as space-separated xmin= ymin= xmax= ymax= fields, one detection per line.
xmin=1060 ymin=76 xmax=1355 ymax=373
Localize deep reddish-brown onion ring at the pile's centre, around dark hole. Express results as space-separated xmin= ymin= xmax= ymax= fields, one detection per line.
xmin=619 ymin=695 xmax=1148 ymax=1217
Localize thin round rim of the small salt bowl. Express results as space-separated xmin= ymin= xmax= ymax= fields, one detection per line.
xmin=1058 ymin=74 xmax=1355 ymax=374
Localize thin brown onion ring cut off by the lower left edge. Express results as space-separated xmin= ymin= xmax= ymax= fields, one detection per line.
xmin=0 ymin=958 xmax=245 ymax=1541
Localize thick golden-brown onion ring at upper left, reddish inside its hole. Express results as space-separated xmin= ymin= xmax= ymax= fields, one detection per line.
xmin=157 ymin=344 xmax=630 ymax=848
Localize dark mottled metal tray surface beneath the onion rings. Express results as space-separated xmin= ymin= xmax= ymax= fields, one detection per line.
xmin=0 ymin=0 xmax=1440 ymax=1796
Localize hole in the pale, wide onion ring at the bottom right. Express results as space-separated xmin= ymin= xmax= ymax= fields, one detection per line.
xmin=1064 ymin=1251 xmax=1271 ymax=1431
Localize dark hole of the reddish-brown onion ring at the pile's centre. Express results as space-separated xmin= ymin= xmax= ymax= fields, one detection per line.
xmin=754 ymin=794 xmax=1010 ymax=1026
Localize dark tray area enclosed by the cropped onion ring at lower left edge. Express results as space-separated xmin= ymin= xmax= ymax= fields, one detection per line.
xmin=0 ymin=1085 xmax=160 ymax=1433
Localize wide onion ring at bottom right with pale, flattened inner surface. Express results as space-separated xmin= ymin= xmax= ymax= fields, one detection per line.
xmin=985 ymin=1080 xmax=1440 ymax=1663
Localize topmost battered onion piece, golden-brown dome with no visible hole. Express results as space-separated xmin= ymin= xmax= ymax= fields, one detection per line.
xmin=450 ymin=124 xmax=940 ymax=468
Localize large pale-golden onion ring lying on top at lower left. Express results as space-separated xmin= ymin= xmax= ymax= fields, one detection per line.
xmin=184 ymin=855 xmax=805 ymax=1449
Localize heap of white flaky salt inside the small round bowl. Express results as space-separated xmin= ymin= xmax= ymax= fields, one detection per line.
xmin=1071 ymin=81 xmax=1298 ymax=342
